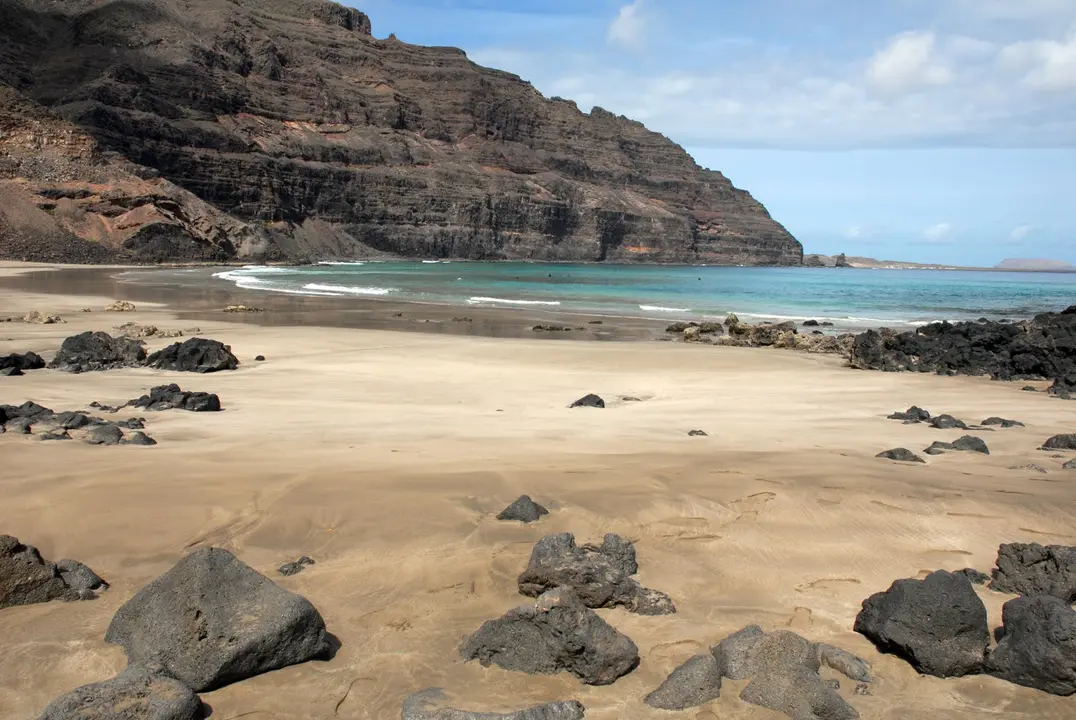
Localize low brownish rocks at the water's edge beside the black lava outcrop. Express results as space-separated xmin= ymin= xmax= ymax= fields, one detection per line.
xmin=665 ymin=314 xmax=854 ymax=355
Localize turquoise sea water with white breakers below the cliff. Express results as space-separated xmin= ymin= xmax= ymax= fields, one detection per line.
xmin=205 ymin=260 xmax=1076 ymax=327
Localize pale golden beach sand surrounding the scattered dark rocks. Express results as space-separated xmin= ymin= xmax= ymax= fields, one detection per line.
xmin=0 ymin=265 xmax=1076 ymax=720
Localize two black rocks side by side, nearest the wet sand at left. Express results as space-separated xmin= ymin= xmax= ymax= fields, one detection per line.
xmin=48 ymin=330 xmax=239 ymax=372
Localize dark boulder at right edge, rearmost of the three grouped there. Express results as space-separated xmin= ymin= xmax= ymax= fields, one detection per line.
xmin=990 ymin=542 xmax=1076 ymax=604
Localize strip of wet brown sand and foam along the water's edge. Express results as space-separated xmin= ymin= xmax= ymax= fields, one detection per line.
xmin=0 ymin=262 xmax=1057 ymax=341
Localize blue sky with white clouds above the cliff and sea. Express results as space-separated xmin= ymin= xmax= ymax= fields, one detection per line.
xmin=351 ymin=0 xmax=1076 ymax=265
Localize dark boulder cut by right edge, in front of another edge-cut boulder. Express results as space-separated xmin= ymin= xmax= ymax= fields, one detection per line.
xmin=987 ymin=595 xmax=1076 ymax=695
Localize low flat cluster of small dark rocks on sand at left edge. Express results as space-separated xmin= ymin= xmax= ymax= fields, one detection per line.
xmin=0 ymin=400 xmax=157 ymax=446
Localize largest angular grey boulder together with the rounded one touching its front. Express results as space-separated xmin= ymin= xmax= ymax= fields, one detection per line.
xmin=41 ymin=548 xmax=334 ymax=720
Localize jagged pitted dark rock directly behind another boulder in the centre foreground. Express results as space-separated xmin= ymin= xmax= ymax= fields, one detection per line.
xmin=519 ymin=533 xmax=676 ymax=615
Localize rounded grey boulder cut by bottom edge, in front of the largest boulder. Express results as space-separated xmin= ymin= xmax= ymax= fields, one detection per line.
xmin=38 ymin=665 xmax=206 ymax=720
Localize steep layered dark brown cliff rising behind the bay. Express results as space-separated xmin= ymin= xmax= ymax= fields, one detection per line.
xmin=0 ymin=0 xmax=803 ymax=265
